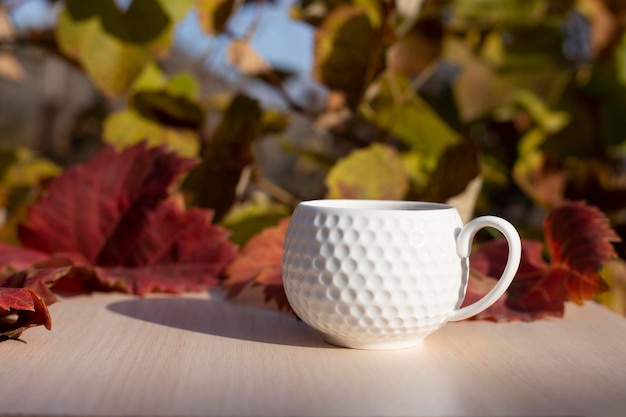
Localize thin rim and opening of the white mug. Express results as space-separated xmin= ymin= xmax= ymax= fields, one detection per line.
xmin=298 ymin=199 xmax=454 ymax=212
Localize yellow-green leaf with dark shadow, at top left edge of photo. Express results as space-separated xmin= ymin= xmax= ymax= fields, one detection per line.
xmin=55 ymin=0 xmax=194 ymax=97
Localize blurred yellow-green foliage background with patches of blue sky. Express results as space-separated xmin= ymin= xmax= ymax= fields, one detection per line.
xmin=0 ymin=0 xmax=626 ymax=313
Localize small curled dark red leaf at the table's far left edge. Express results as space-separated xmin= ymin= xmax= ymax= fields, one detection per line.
xmin=0 ymin=268 xmax=69 ymax=340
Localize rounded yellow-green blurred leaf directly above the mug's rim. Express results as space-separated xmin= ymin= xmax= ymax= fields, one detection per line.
xmin=326 ymin=143 xmax=409 ymax=200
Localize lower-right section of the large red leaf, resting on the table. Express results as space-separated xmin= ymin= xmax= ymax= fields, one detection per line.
xmin=92 ymin=196 xmax=235 ymax=294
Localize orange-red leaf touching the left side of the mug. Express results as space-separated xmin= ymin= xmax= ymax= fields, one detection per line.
xmin=225 ymin=219 xmax=290 ymax=310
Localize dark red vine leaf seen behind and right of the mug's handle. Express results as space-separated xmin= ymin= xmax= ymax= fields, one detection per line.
xmin=464 ymin=202 xmax=619 ymax=320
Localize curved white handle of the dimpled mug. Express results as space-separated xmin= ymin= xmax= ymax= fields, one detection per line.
xmin=448 ymin=216 xmax=522 ymax=321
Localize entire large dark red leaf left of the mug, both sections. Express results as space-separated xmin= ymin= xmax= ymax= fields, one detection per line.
xmin=0 ymin=142 xmax=237 ymax=295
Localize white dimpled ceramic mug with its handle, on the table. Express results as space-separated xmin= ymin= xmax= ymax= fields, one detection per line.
xmin=282 ymin=200 xmax=521 ymax=349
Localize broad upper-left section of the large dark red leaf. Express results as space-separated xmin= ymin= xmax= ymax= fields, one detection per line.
xmin=19 ymin=143 xmax=196 ymax=264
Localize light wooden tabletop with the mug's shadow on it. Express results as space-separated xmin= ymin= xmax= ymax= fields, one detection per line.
xmin=0 ymin=294 xmax=626 ymax=417
